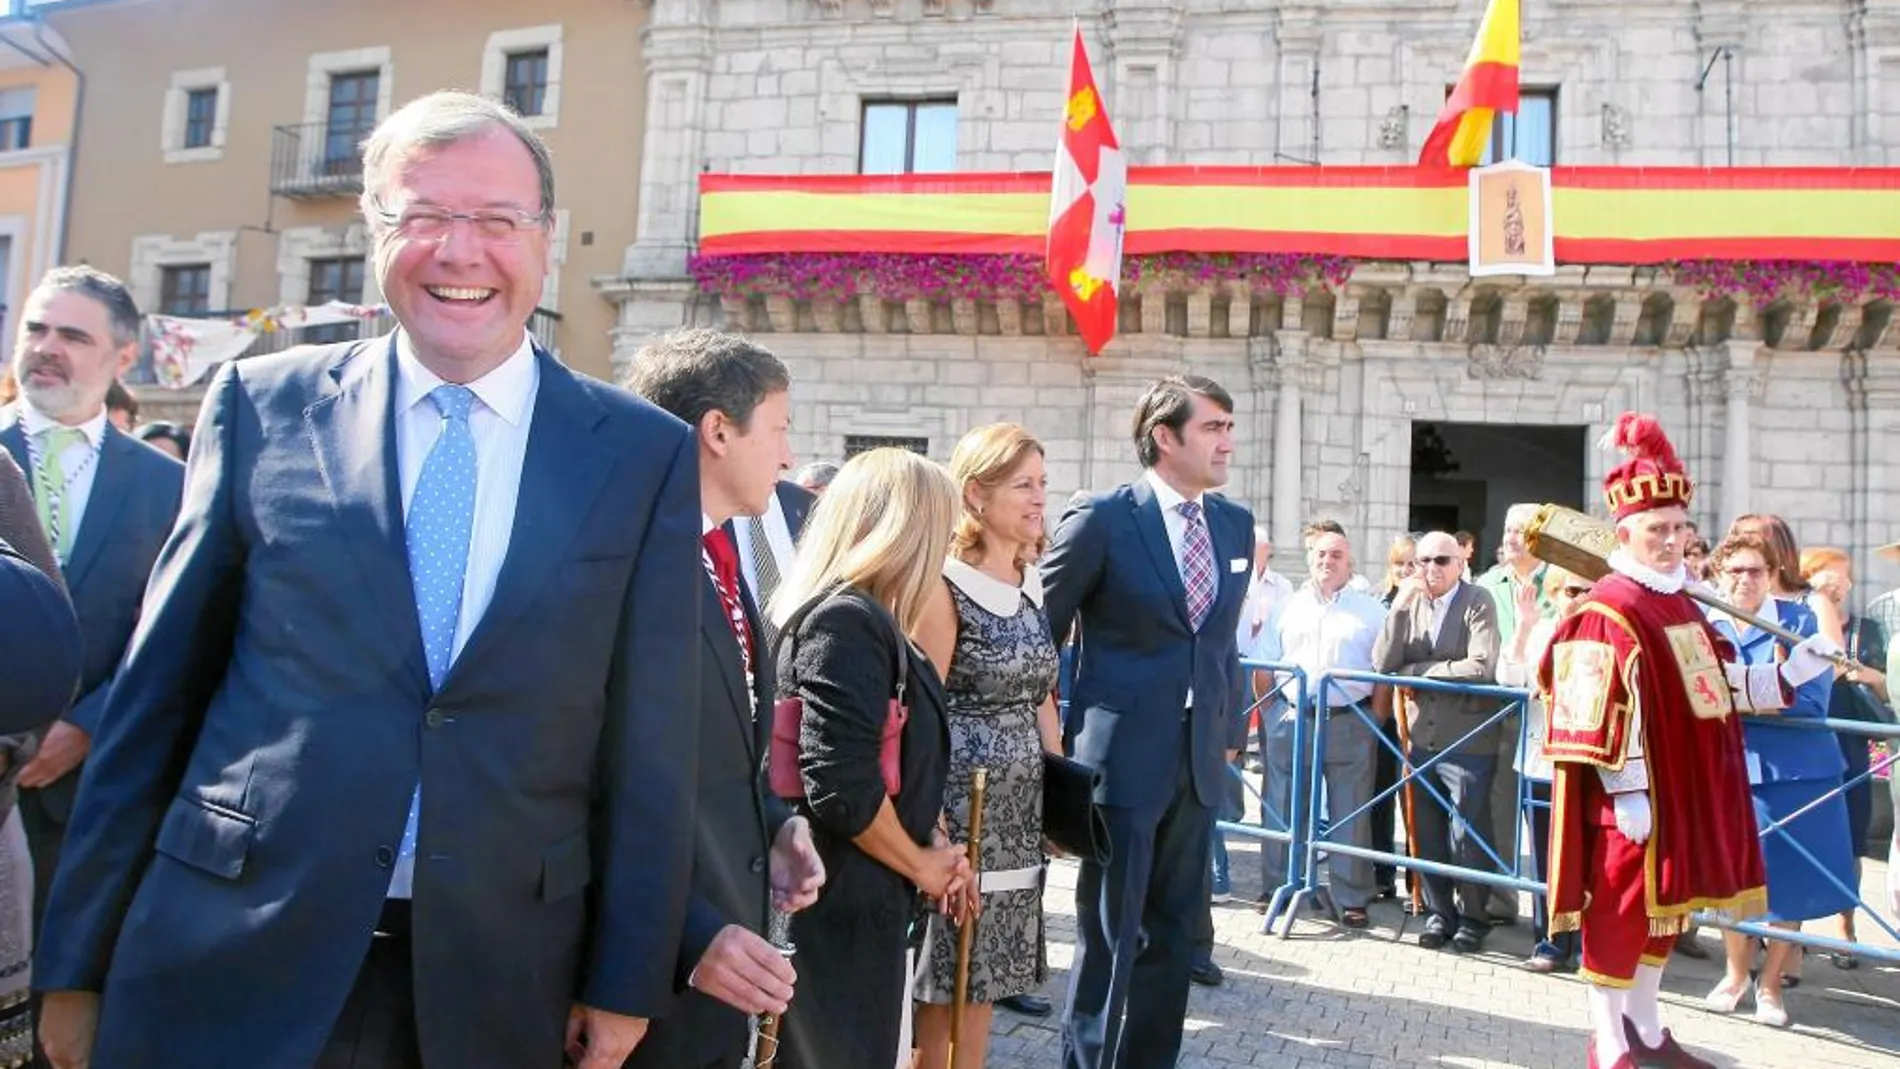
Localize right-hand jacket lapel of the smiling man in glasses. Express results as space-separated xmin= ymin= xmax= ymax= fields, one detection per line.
xmin=443 ymin=347 xmax=614 ymax=689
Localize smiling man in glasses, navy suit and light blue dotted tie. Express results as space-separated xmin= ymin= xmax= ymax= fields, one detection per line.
xmin=34 ymin=93 xmax=701 ymax=1069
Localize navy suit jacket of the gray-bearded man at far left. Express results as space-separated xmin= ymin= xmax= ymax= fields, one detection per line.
xmin=0 ymin=406 xmax=184 ymax=820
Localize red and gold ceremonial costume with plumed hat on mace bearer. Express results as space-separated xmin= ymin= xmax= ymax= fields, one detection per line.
xmin=1537 ymin=418 xmax=1767 ymax=987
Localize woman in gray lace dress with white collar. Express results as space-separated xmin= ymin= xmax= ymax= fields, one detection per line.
xmin=916 ymin=423 xmax=1060 ymax=1069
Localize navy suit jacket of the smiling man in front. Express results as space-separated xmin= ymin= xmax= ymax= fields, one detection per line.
xmin=34 ymin=340 xmax=701 ymax=1069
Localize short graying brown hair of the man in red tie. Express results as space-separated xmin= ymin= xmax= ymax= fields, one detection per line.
xmin=625 ymin=327 xmax=792 ymax=431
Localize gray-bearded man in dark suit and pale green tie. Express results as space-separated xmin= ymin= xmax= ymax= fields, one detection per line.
xmin=0 ymin=268 xmax=184 ymax=953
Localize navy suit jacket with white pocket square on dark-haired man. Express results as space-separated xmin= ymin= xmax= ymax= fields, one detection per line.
xmin=1039 ymin=478 xmax=1254 ymax=807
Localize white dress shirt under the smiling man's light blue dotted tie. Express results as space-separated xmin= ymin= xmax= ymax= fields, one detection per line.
xmin=395 ymin=332 xmax=542 ymax=665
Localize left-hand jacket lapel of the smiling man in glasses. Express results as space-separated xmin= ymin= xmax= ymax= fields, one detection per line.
xmin=304 ymin=334 xmax=429 ymax=691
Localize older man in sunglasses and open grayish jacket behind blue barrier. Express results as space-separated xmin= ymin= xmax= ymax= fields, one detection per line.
xmin=1372 ymin=532 xmax=1516 ymax=953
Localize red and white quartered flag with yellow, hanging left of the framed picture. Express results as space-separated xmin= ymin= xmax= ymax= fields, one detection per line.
xmin=1047 ymin=27 xmax=1129 ymax=353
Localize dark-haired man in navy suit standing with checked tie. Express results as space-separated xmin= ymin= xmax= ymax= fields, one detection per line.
xmin=1043 ymin=376 xmax=1254 ymax=1069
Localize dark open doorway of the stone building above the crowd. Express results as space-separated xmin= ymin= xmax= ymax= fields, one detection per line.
xmin=1410 ymin=422 xmax=1588 ymax=573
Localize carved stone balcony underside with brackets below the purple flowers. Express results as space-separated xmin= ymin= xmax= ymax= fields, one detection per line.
xmin=720 ymin=262 xmax=1900 ymax=351
